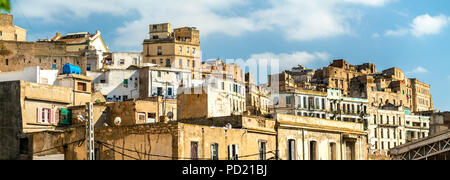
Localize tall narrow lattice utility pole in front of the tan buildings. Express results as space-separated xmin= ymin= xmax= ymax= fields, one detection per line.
xmin=86 ymin=102 xmax=95 ymax=160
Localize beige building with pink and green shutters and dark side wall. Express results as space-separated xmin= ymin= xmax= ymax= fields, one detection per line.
xmin=0 ymin=81 xmax=90 ymax=160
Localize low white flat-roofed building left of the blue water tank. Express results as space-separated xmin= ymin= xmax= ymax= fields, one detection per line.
xmin=0 ymin=66 xmax=59 ymax=85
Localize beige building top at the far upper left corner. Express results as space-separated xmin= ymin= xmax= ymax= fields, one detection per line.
xmin=0 ymin=14 xmax=27 ymax=41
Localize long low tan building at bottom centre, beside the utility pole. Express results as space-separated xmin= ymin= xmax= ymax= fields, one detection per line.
xmin=54 ymin=116 xmax=276 ymax=160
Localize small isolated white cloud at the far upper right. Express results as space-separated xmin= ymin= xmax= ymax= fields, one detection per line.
xmin=384 ymin=14 xmax=450 ymax=37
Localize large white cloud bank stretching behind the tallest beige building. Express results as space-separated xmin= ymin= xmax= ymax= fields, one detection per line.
xmin=15 ymin=0 xmax=395 ymax=47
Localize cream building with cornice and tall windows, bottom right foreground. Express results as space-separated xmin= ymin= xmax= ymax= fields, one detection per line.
xmin=276 ymin=114 xmax=367 ymax=160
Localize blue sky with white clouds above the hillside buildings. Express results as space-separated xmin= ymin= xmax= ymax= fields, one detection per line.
xmin=7 ymin=0 xmax=450 ymax=111
